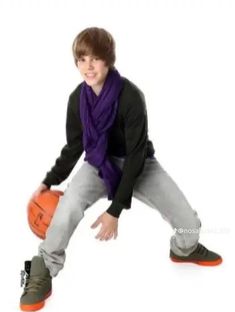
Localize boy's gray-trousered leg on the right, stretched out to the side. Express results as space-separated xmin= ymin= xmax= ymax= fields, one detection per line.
xmin=133 ymin=158 xmax=201 ymax=256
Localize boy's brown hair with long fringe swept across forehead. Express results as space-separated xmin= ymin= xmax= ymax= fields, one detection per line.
xmin=72 ymin=27 xmax=116 ymax=68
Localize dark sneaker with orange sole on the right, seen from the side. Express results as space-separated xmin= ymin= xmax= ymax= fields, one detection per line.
xmin=170 ymin=243 xmax=223 ymax=266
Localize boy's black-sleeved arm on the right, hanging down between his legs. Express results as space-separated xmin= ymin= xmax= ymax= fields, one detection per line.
xmin=107 ymin=92 xmax=148 ymax=218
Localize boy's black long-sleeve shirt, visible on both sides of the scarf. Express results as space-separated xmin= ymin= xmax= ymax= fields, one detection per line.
xmin=42 ymin=77 xmax=155 ymax=218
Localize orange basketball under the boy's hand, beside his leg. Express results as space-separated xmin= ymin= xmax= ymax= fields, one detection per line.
xmin=27 ymin=190 xmax=64 ymax=239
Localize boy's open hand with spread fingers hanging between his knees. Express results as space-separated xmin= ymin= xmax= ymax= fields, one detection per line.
xmin=91 ymin=212 xmax=118 ymax=241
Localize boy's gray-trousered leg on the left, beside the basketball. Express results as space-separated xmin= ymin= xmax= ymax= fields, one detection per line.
xmin=39 ymin=162 xmax=106 ymax=277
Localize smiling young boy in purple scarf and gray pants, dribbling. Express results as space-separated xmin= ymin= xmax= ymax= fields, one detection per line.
xmin=20 ymin=27 xmax=222 ymax=311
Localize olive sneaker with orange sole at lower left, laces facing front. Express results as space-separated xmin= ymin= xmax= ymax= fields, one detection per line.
xmin=20 ymin=256 xmax=52 ymax=311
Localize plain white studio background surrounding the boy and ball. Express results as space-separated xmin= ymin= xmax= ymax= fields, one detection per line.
xmin=0 ymin=0 xmax=235 ymax=312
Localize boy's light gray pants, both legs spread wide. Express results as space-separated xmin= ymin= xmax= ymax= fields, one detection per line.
xmin=39 ymin=157 xmax=201 ymax=277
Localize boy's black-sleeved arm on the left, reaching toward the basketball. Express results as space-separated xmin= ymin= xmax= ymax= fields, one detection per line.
xmin=42 ymin=96 xmax=84 ymax=188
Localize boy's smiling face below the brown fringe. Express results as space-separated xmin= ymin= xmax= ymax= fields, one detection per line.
xmin=77 ymin=55 xmax=109 ymax=95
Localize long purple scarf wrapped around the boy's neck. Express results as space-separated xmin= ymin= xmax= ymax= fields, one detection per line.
xmin=80 ymin=69 xmax=123 ymax=200
